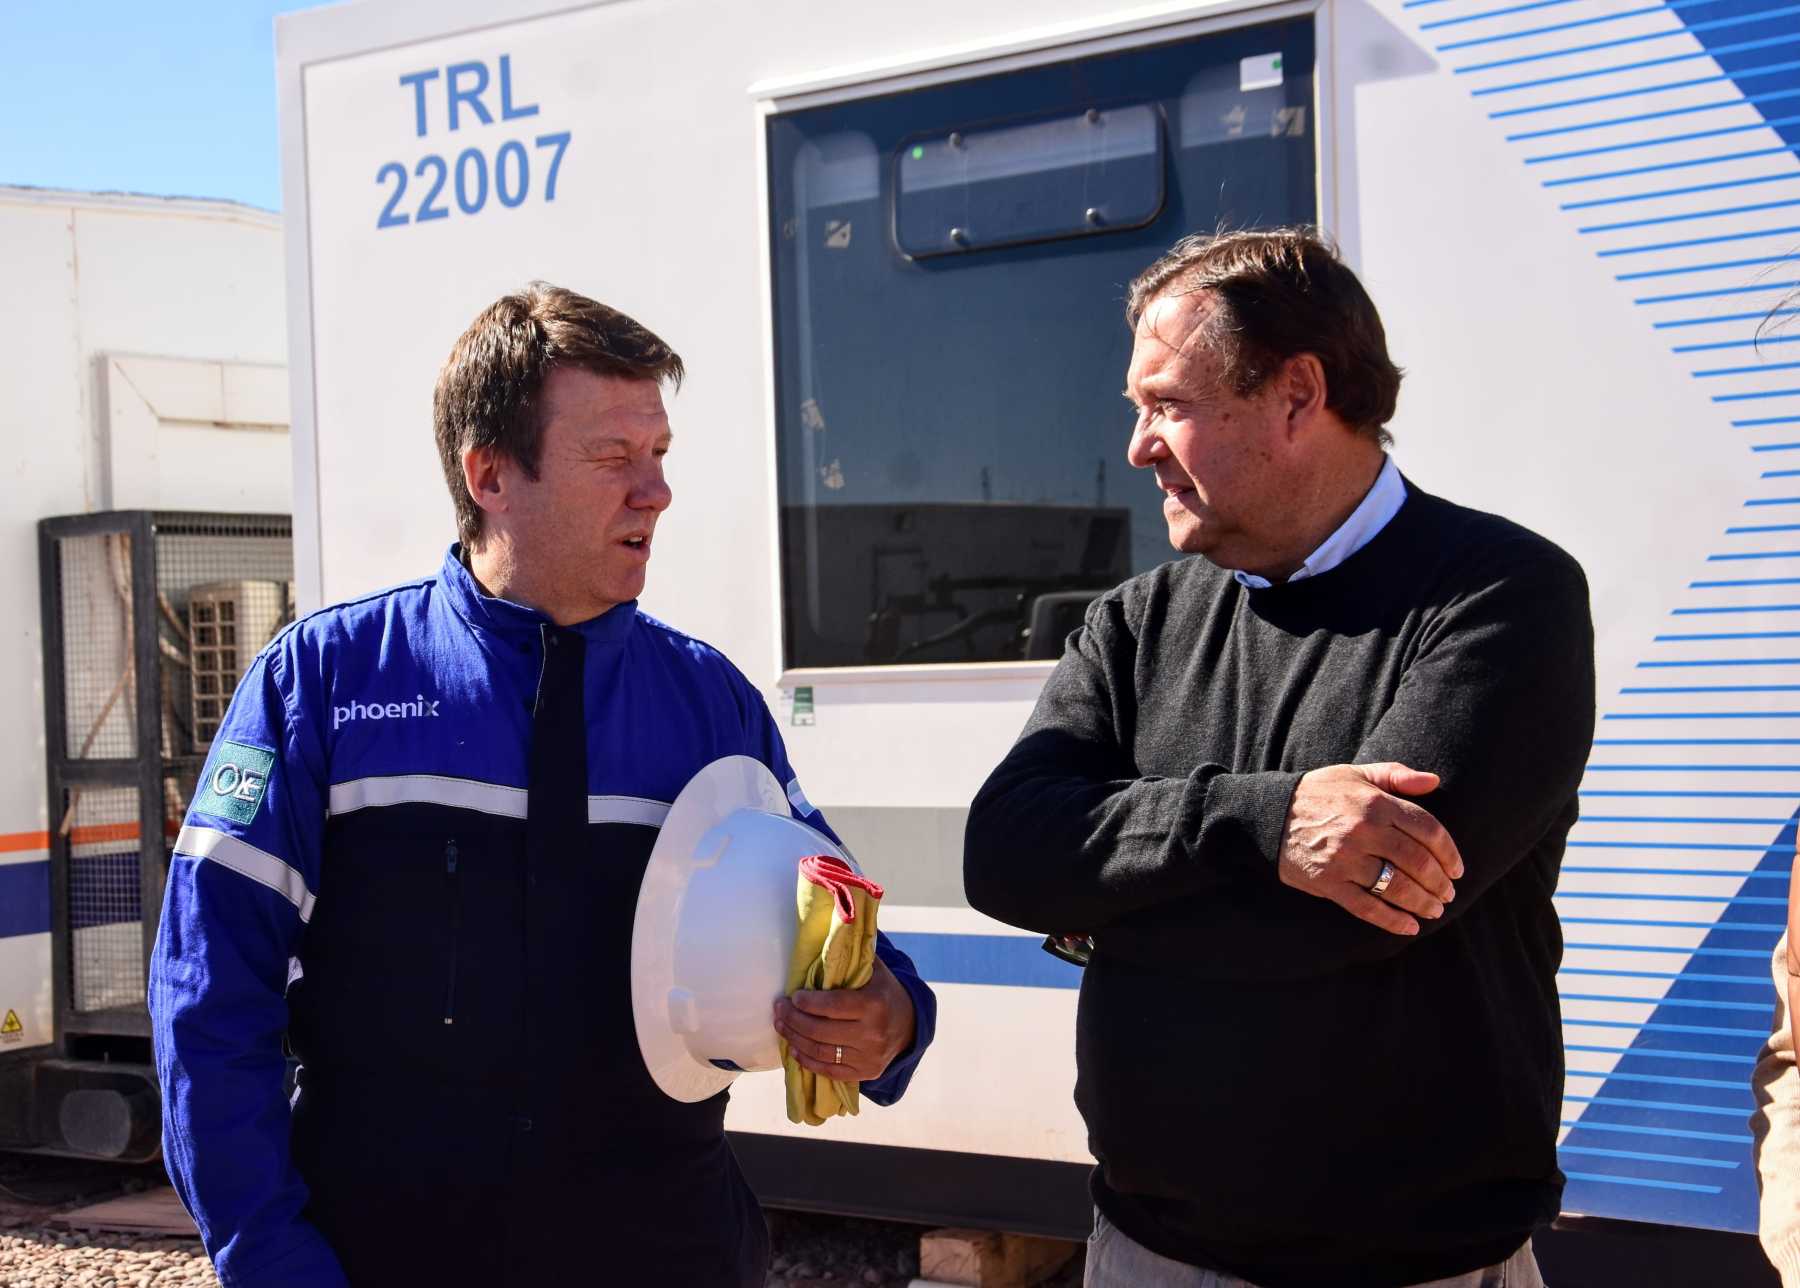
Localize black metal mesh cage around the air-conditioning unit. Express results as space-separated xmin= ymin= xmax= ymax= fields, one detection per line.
xmin=38 ymin=511 xmax=293 ymax=1052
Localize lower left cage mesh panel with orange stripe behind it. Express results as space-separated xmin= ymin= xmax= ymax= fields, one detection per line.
xmin=65 ymin=788 xmax=144 ymax=1011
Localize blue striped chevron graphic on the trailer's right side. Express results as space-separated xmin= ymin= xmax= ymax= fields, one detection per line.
xmin=1402 ymin=0 xmax=1800 ymax=1230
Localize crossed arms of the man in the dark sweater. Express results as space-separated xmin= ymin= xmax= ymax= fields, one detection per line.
xmin=965 ymin=556 xmax=1593 ymax=975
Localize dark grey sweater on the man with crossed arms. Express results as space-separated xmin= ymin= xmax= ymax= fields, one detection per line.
xmin=965 ymin=487 xmax=1593 ymax=1288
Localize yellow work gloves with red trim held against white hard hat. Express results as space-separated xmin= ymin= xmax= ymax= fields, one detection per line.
xmin=781 ymin=854 xmax=882 ymax=1126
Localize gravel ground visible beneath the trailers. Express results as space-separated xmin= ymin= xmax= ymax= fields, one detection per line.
xmin=0 ymin=1171 xmax=1082 ymax=1288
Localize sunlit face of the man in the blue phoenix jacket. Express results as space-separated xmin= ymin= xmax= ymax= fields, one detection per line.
xmin=508 ymin=367 xmax=673 ymax=619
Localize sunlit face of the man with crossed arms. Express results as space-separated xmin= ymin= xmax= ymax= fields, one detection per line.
xmin=1125 ymin=291 xmax=1289 ymax=568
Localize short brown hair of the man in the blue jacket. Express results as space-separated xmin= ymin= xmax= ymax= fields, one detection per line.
xmin=432 ymin=282 xmax=686 ymax=549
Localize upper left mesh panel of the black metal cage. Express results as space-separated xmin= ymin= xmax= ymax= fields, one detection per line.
xmin=61 ymin=532 xmax=137 ymax=761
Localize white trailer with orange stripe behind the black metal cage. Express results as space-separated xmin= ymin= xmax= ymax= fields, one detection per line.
xmin=0 ymin=187 xmax=292 ymax=1149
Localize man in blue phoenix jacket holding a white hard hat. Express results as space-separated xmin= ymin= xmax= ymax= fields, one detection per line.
xmin=149 ymin=284 xmax=936 ymax=1288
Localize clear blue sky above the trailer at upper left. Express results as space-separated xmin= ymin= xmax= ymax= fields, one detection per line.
xmin=0 ymin=0 xmax=340 ymax=210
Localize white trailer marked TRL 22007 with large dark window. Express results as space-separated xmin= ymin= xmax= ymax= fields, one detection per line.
xmin=277 ymin=0 xmax=1800 ymax=1266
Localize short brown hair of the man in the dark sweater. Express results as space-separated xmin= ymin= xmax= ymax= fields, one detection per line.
xmin=1125 ymin=228 xmax=1400 ymax=446
